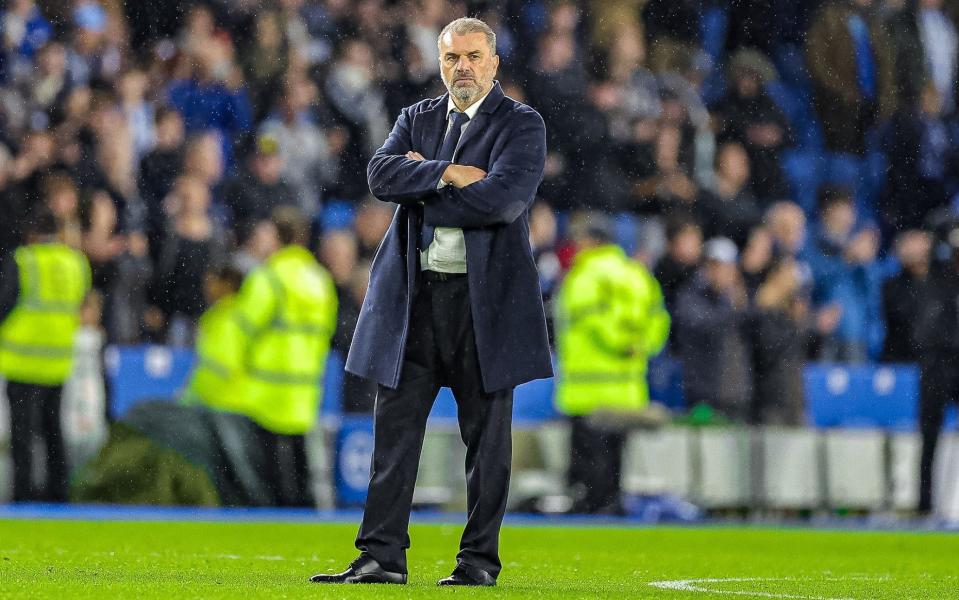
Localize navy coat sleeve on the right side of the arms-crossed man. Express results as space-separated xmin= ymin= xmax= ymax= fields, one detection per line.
xmin=423 ymin=111 xmax=546 ymax=228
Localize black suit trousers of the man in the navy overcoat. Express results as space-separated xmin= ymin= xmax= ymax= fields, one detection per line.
xmin=356 ymin=273 xmax=521 ymax=578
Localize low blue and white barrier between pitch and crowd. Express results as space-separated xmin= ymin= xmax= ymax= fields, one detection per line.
xmin=0 ymin=346 xmax=959 ymax=521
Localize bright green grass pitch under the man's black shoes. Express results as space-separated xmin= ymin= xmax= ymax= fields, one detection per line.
xmin=0 ymin=520 xmax=959 ymax=600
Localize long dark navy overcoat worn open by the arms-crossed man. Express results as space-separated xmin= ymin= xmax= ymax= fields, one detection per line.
xmin=346 ymin=82 xmax=552 ymax=392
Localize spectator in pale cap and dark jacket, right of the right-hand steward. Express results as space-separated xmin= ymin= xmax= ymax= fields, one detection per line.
xmin=675 ymin=238 xmax=753 ymax=423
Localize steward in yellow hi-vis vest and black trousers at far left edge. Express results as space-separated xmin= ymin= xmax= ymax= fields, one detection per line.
xmin=0 ymin=209 xmax=91 ymax=502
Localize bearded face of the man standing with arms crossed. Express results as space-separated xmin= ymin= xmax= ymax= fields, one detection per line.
xmin=439 ymin=32 xmax=499 ymax=106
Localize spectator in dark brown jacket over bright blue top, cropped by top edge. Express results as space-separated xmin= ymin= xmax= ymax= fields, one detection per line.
xmin=806 ymin=0 xmax=896 ymax=155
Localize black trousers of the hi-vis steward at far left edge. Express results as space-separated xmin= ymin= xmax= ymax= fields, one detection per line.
xmin=7 ymin=381 xmax=67 ymax=502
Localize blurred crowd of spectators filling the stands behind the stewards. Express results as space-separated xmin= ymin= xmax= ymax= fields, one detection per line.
xmin=0 ymin=0 xmax=959 ymax=424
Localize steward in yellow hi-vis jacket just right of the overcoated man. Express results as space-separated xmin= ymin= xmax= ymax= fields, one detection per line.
xmin=556 ymin=213 xmax=670 ymax=514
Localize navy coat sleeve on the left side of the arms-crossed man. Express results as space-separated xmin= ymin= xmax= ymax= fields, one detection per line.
xmin=366 ymin=108 xmax=450 ymax=205
